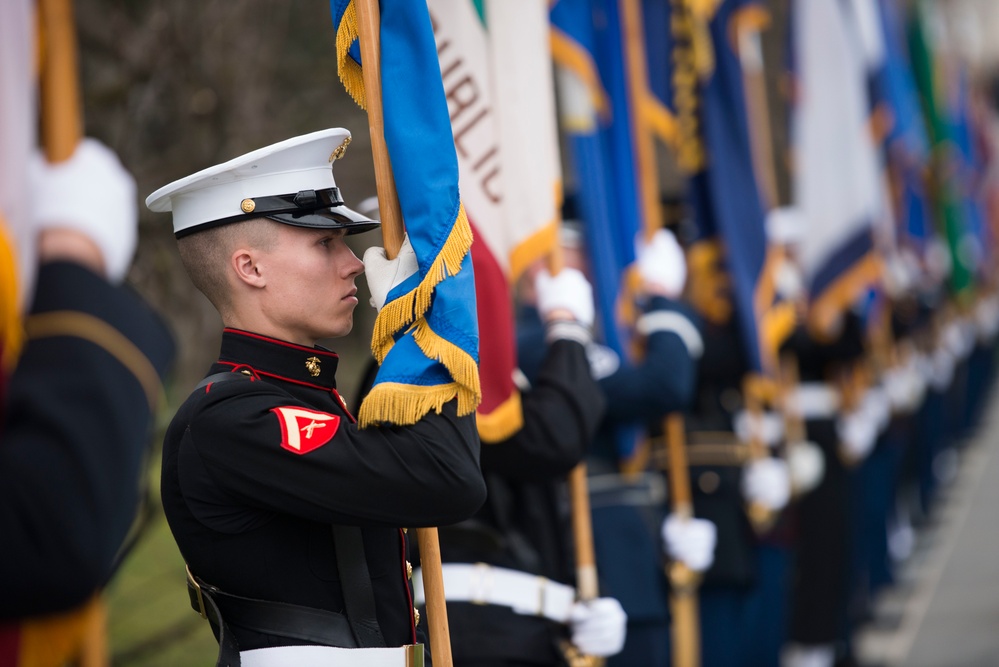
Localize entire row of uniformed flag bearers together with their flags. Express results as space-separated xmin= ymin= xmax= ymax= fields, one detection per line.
xmin=0 ymin=0 xmax=999 ymax=667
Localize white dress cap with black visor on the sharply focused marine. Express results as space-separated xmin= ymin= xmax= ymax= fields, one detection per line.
xmin=146 ymin=128 xmax=378 ymax=237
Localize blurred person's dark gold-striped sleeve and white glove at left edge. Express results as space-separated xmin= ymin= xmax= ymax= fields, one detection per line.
xmin=0 ymin=139 xmax=174 ymax=665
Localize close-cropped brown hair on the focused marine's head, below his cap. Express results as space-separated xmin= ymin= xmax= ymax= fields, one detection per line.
xmin=177 ymin=218 xmax=277 ymax=319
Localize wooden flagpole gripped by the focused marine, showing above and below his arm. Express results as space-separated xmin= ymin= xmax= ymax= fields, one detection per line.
xmin=354 ymin=0 xmax=453 ymax=667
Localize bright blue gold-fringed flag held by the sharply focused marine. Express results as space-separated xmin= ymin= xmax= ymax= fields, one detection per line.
xmin=330 ymin=0 xmax=481 ymax=426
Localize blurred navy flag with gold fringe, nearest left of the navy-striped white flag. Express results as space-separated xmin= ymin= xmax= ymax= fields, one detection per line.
xmin=684 ymin=0 xmax=795 ymax=374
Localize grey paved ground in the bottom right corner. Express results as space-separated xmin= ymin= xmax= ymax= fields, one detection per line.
xmin=857 ymin=392 xmax=999 ymax=667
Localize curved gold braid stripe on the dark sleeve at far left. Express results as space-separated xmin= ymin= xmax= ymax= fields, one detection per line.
xmin=24 ymin=310 xmax=163 ymax=410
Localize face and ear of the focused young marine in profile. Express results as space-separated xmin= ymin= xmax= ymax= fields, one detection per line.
xmin=260 ymin=224 xmax=364 ymax=345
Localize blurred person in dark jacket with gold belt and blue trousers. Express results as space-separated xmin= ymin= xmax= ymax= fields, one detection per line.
xmin=687 ymin=206 xmax=807 ymax=667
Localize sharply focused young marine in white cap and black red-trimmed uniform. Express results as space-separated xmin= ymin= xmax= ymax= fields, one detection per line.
xmin=147 ymin=129 xmax=485 ymax=666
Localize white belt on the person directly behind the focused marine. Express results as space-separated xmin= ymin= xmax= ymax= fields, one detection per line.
xmin=413 ymin=563 xmax=576 ymax=623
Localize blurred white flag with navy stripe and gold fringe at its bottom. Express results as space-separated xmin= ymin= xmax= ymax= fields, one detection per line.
xmin=791 ymin=0 xmax=888 ymax=335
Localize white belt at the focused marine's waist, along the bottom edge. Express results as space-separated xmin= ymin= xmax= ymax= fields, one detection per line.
xmin=239 ymin=644 xmax=423 ymax=667
